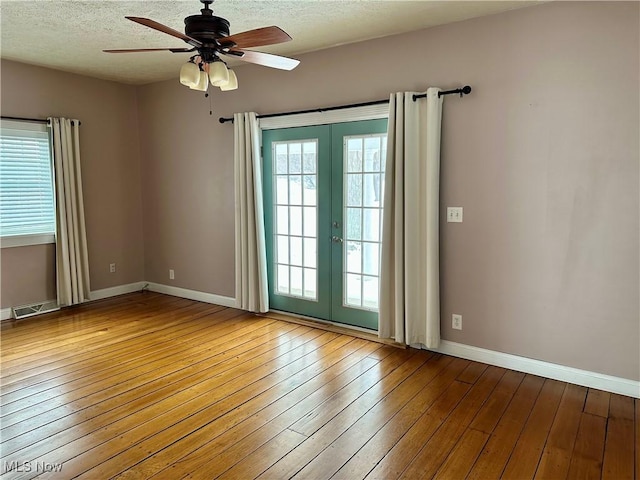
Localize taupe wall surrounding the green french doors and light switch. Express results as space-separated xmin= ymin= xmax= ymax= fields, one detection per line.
xmin=138 ymin=2 xmax=640 ymax=380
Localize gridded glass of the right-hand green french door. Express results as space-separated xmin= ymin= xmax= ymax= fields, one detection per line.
xmin=343 ymin=134 xmax=387 ymax=311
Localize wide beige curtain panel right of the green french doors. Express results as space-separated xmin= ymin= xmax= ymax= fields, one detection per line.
xmin=378 ymin=88 xmax=442 ymax=348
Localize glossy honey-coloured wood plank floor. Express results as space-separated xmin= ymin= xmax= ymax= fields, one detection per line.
xmin=0 ymin=292 xmax=640 ymax=480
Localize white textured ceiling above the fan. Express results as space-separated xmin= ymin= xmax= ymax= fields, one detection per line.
xmin=0 ymin=0 xmax=539 ymax=84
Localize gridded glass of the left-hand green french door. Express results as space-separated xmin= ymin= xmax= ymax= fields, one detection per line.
xmin=272 ymin=139 xmax=318 ymax=301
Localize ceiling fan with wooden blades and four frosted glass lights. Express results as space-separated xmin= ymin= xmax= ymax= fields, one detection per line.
xmin=103 ymin=0 xmax=300 ymax=91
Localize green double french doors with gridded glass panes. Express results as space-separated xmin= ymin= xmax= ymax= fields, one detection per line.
xmin=263 ymin=119 xmax=387 ymax=330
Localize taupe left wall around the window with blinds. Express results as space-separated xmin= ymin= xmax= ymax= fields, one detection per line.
xmin=0 ymin=60 xmax=144 ymax=308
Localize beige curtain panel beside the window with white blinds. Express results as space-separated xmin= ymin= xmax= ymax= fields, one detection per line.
xmin=49 ymin=118 xmax=91 ymax=306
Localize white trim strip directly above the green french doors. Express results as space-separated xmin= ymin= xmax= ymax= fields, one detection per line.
xmin=258 ymin=103 xmax=389 ymax=130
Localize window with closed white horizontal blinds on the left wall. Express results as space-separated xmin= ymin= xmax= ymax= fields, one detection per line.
xmin=0 ymin=119 xmax=56 ymax=248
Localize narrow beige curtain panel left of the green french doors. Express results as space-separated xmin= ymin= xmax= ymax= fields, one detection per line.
xmin=233 ymin=112 xmax=269 ymax=312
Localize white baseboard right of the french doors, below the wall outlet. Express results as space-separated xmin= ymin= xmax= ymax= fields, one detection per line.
xmin=430 ymin=340 xmax=640 ymax=398
